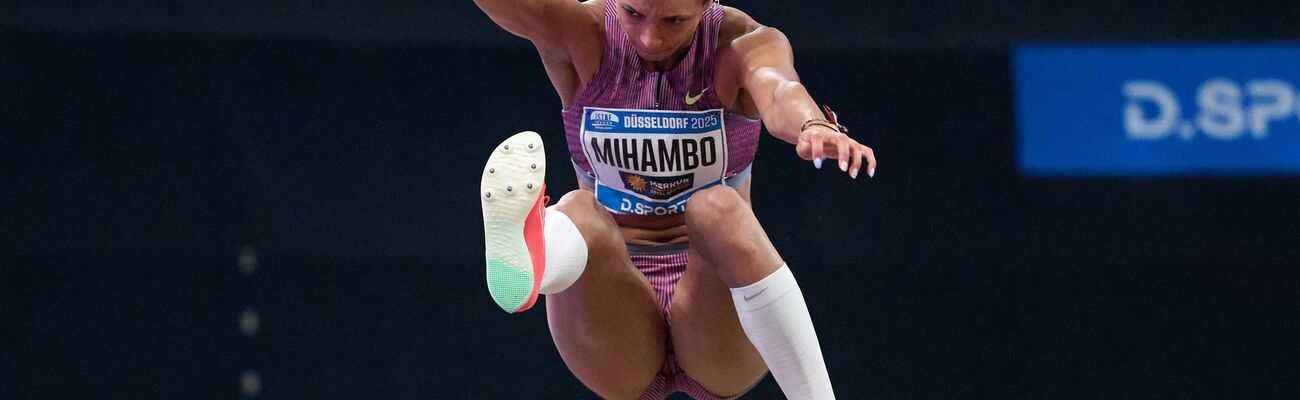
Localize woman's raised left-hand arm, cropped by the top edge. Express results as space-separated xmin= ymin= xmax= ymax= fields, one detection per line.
xmin=475 ymin=0 xmax=585 ymax=44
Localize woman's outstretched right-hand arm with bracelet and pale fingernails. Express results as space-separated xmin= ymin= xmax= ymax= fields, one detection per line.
xmin=732 ymin=26 xmax=876 ymax=178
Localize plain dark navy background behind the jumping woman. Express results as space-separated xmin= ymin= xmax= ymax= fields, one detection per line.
xmin=0 ymin=0 xmax=1300 ymax=399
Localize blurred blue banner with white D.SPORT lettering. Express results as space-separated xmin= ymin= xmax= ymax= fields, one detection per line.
xmin=1013 ymin=44 xmax=1300 ymax=177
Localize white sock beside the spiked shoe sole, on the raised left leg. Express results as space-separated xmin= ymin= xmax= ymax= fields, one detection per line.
xmin=541 ymin=206 xmax=586 ymax=295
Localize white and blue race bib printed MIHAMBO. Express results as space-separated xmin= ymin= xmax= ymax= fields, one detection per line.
xmin=581 ymin=106 xmax=727 ymax=216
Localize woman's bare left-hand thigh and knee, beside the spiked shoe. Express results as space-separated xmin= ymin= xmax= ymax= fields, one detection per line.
xmin=545 ymin=190 xmax=667 ymax=399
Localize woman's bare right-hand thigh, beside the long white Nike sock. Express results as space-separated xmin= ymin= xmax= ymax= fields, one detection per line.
xmin=671 ymin=247 xmax=767 ymax=396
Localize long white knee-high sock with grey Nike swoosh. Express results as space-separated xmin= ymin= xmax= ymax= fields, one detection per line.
xmin=731 ymin=264 xmax=835 ymax=400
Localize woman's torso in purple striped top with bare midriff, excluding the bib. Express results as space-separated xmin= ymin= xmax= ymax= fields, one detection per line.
xmin=538 ymin=0 xmax=759 ymax=244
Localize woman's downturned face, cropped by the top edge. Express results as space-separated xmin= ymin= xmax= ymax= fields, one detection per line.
xmin=610 ymin=0 xmax=709 ymax=61
